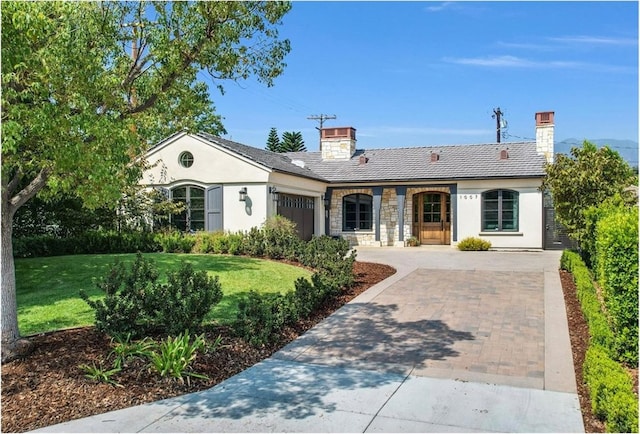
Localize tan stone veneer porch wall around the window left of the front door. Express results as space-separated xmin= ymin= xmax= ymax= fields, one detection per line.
xmin=330 ymin=186 xmax=450 ymax=246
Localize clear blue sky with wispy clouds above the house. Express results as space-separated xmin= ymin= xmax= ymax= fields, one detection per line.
xmin=212 ymin=1 xmax=638 ymax=151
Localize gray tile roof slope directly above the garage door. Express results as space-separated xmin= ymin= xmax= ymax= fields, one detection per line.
xmin=196 ymin=133 xmax=329 ymax=182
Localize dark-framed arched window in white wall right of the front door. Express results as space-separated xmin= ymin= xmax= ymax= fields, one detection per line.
xmin=482 ymin=190 xmax=519 ymax=232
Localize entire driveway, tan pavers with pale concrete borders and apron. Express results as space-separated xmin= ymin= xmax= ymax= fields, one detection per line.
xmin=39 ymin=247 xmax=584 ymax=432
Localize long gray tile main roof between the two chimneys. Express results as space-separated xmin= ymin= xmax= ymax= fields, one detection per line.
xmin=285 ymin=142 xmax=545 ymax=183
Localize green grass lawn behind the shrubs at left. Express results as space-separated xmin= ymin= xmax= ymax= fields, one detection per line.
xmin=16 ymin=253 xmax=311 ymax=336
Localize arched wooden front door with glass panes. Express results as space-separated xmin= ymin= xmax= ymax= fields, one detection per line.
xmin=413 ymin=191 xmax=451 ymax=244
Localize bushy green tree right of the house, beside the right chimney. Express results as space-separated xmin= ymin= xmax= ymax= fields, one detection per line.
xmin=541 ymin=140 xmax=637 ymax=241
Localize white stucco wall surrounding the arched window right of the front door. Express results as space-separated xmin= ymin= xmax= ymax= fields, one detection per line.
xmin=457 ymin=179 xmax=543 ymax=249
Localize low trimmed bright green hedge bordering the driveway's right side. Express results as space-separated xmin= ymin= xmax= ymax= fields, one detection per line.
xmin=560 ymin=251 xmax=638 ymax=432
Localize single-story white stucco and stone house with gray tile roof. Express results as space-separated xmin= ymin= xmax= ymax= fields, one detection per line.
xmin=141 ymin=112 xmax=558 ymax=249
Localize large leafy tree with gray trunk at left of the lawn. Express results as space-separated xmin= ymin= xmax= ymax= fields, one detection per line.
xmin=0 ymin=1 xmax=290 ymax=360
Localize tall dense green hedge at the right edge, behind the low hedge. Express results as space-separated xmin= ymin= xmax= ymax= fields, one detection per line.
xmin=596 ymin=207 xmax=638 ymax=365
